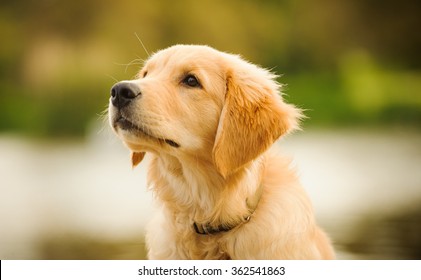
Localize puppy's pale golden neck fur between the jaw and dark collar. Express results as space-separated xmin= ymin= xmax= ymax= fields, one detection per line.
xmin=149 ymin=153 xmax=264 ymax=233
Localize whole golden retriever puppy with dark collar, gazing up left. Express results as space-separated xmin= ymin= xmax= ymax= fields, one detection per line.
xmin=109 ymin=45 xmax=334 ymax=259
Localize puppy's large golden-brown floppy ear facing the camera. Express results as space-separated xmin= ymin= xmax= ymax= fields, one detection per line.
xmin=213 ymin=65 xmax=301 ymax=177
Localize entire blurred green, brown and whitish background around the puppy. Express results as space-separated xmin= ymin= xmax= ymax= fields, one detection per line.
xmin=0 ymin=0 xmax=421 ymax=259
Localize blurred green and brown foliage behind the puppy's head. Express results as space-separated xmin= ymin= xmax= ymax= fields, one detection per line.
xmin=0 ymin=0 xmax=421 ymax=137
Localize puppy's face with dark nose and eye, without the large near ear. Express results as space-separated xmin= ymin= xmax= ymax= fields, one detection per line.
xmin=109 ymin=45 xmax=225 ymax=165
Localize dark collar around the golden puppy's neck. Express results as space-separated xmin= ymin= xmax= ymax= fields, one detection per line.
xmin=193 ymin=184 xmax=263 ymax=235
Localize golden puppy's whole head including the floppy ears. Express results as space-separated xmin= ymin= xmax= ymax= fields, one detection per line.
xmin=109 ymin=45 xmax=300 ymax=173
